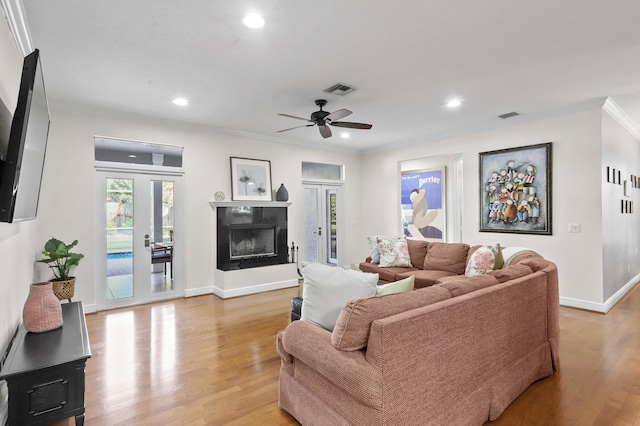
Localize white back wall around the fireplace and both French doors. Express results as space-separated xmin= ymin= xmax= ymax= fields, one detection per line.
xmin=40 ymin=108 xmax=362 ymax=311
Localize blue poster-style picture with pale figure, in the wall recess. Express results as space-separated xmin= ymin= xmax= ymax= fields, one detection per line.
xmin=400 ymin=167 xmax=446 ymax=241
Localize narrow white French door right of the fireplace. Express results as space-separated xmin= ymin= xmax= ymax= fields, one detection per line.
xmin=304 ymin=183 xmax=342 ymax=266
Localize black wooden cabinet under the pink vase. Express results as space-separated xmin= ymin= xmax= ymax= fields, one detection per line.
xmin=0 ymin=302 xmax=91 ymax=426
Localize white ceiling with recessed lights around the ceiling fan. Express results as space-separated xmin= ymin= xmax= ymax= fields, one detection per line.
xmin=16 ymin=0 xmax=640 ymax=150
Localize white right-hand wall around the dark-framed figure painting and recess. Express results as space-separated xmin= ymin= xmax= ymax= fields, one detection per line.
xmin=359 ymin=108 xmax=603 ymax=310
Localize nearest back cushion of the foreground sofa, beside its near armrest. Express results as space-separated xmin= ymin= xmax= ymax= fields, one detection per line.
xmin=331 ymin=287 xmax=451 ymax=351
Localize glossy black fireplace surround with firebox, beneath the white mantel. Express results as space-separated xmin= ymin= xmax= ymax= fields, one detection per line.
xmin=216 ymin=205 xmax=289 ymax=271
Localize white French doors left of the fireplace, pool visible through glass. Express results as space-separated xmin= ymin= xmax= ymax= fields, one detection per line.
xmin=96 ymin=170 xmax=184 ymax=309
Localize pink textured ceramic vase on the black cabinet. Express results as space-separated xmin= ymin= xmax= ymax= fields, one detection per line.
xmin=22 ymin=282 xmax=62 ymax=333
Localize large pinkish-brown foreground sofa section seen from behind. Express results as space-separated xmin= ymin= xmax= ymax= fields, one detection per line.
xmin=276 ymin=250 xmax=559 ymax=426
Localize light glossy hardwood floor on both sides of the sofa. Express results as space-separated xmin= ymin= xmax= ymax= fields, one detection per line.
xmin=56 ymin=286 xmax=640 ymax=426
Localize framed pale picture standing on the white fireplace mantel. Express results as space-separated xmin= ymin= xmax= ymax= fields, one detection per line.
xmin=231 ymin=157 xmax=271 ymax=201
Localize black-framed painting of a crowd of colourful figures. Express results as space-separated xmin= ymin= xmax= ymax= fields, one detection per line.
xmin=480 ymin=142 xmax=552 ymax=235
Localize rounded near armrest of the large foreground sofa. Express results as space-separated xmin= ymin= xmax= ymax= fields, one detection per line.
xmin=278 ymin=321 xmax=381 ymax=404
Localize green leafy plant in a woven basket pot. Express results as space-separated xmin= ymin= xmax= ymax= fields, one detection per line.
xmin=38 ymin=238 xmax=84 ymax=302
